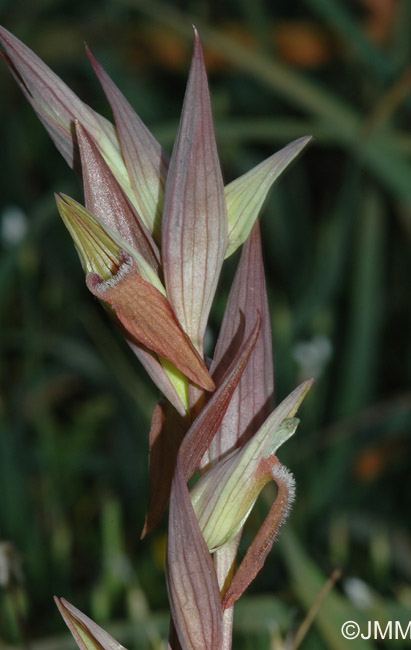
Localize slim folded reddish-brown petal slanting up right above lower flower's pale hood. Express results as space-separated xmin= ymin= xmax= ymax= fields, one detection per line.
xmin=180 ymin=316 xmax=261 ymax=481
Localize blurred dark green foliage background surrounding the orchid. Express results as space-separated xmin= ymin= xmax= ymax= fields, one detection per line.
xmin=0 ymin=0 xmax=411 ymax=650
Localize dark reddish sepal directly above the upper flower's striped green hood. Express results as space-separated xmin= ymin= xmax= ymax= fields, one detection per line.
xmin=76 ymin=122 xmax=160 ymax=272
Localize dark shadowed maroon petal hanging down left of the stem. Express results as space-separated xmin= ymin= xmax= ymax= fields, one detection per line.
xmin=141 ymin=403 xmax=188 ymax=538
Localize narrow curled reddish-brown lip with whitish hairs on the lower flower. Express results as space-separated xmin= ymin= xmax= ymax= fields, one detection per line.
xmin=223 ymin=456 xmax=295 ymax=609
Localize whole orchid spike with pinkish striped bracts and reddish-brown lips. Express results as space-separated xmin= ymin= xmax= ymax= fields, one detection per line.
xmin=0 ymin=27 xmax=311 ymax=650
